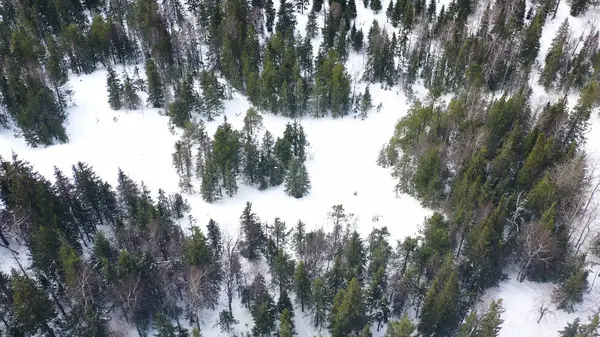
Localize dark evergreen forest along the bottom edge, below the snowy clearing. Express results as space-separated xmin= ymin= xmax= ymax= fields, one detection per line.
xmin=0 ymin=157 xmax=599 ymax=337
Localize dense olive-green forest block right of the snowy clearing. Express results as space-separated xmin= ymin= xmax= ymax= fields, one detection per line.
xmin=378 ymin=51 xmax=600 ymax=335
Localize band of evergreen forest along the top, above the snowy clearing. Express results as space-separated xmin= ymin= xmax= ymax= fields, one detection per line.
xmin=0 ymin=0 xmax=600 ymax=146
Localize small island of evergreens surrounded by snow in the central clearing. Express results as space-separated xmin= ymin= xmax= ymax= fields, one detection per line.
xmin=173 ymin=108 xmax=310 ymax=202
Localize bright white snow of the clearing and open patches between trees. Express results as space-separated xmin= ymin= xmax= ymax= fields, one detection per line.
xmin=0 ymin=0 xmax=600 ymax=337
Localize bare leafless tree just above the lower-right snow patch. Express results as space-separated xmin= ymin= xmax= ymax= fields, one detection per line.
xmin=518 ymin=222 xmax=557 ymax=282
